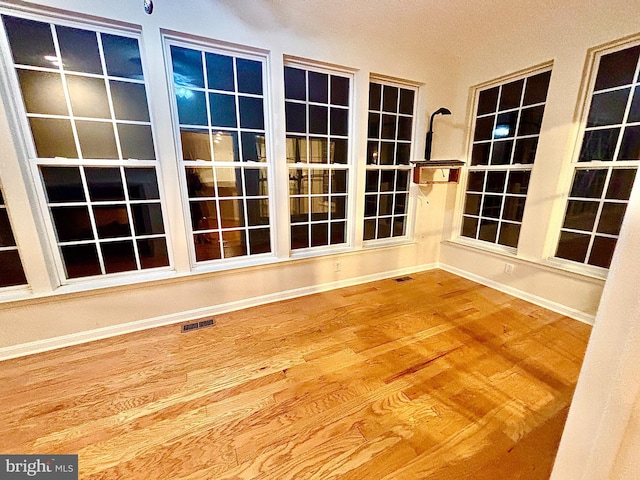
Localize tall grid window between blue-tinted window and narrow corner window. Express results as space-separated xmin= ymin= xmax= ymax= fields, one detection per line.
xmin=284 ymin=66 xmax=351 ymax=250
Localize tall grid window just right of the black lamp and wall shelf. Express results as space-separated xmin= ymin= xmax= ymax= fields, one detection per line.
xmin=461 ymin=71 xmax=551 ymax=248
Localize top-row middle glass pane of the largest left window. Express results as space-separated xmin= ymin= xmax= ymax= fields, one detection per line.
xmin=56 ymin=26 xmax=102 ymax=74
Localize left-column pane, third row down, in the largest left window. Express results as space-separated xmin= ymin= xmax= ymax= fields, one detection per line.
xmin=29 ymin=118 xmax=78 ymax=158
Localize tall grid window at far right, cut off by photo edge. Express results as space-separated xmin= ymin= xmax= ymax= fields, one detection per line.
xmin=556 ymin=46 xmax=640 ymax=268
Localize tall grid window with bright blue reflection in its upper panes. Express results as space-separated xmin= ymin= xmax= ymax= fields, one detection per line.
xmin=170 ymin=44 xmax=271 ymax=262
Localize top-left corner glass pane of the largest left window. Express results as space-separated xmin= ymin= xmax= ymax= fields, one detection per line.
xmin=2 ymin=15 xmax=56 ymax=68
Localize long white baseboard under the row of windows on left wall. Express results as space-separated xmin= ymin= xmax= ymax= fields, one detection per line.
xmin=0 ymin=263 xmax=438 ymax=361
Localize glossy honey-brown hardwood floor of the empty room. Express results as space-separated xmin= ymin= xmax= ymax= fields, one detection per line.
xmin=0 ymin=270 xmax=591 ymax=480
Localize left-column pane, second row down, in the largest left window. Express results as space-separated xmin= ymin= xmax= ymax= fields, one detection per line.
xmin=18 ymin=70 xmax=69 ymax=115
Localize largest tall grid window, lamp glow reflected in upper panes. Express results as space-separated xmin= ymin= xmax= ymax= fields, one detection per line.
xmin=2 ymin=15 xmax=169 ymax=278
